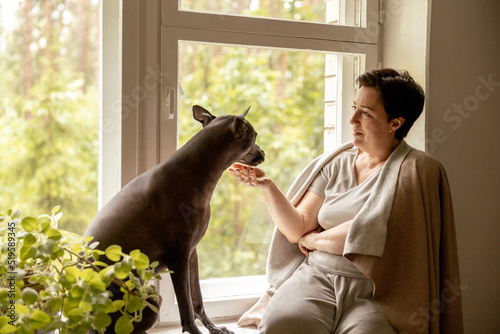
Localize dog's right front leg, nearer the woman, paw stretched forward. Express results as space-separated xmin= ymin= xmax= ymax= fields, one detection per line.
xmin=189 ymin=249 xmax=234 ymax=334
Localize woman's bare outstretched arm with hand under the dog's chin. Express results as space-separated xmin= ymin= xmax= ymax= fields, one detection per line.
xmin=228 ymin=164 xmax=324 ymax=243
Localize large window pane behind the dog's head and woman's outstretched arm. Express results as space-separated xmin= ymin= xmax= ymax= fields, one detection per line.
xmin=179 ymin=42 xmax=362 ymax=278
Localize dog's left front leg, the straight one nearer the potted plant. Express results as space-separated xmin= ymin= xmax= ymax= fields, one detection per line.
xmin=169 ymin=255 xmax=202 ymax=334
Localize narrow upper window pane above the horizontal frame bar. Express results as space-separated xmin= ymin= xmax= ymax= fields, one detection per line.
xmin=181 ymin=0 xmax=366 ymax=27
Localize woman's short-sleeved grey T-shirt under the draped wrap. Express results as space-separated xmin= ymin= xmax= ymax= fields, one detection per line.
xmin=309 ymin=146 xmax=381 ymax=230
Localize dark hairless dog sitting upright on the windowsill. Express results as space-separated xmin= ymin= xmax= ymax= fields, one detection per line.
xmin=85 ymin=106 xmax=264 ymax=334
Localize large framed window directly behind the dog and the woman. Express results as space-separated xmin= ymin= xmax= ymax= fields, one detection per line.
xmin=101 ymin=0 xmax=378 ymax=323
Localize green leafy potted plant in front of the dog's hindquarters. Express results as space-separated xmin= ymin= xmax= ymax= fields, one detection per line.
xmin=0 ymin=207 xmax=160 ymax=334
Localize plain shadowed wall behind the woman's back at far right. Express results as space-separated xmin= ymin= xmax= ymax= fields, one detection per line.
xmin=426 ymin=0 xmax=500 ymax=334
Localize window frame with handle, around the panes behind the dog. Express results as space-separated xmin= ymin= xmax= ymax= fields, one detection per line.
xmin=99 ymin=0 xmax=378 ymax=324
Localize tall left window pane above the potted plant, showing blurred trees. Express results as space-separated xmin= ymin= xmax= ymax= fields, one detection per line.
xmin=0 ymin=0 xmax=99 ymax=234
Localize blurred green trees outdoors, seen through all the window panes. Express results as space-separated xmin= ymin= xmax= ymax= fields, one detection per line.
xmin=0 ymin=0 xmax=325 ymax=278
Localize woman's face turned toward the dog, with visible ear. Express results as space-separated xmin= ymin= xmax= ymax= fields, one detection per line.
xmin=350 ymin=86 xmax=404 ymax=155
